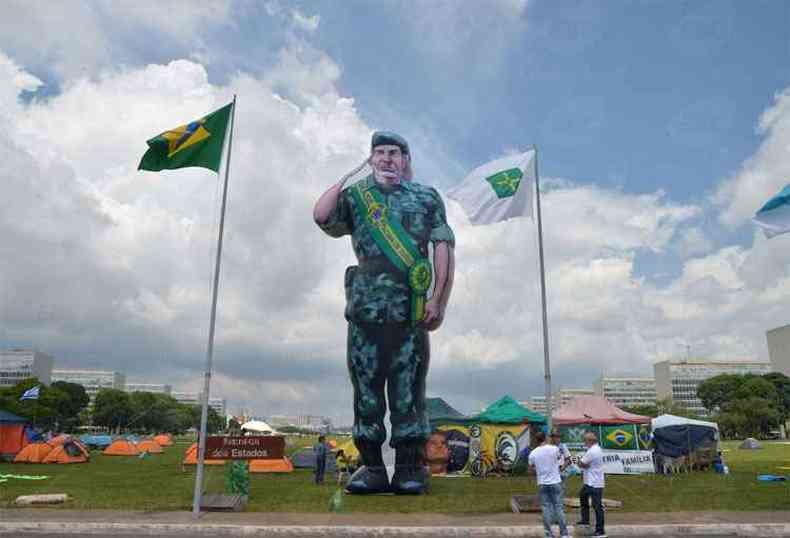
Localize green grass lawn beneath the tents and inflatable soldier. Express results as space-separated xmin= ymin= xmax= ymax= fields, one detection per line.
xmin=0 ymin=438 xmax=790 ymax=513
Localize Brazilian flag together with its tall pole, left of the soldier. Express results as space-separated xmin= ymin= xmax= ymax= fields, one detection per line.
xmin=138 ymin=95 xmax=236 ymax=517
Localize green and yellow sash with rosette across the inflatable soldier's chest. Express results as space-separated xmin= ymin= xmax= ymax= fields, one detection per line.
xmin=351 ymin=182 xmax=433 ymax=325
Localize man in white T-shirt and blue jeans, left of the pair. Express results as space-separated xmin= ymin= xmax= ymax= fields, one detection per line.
xmin=529 ymin=432 xmax=569 ymax=538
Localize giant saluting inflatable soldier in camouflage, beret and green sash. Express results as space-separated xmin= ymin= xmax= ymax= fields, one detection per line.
xmin=313 ymin=132 xmax=455 ymax=494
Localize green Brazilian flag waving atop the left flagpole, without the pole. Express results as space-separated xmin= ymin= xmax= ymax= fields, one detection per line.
xmin=137 ymin=103 xmax=233 ymax=172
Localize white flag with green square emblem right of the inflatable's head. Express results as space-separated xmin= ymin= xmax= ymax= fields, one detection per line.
xmin=447 ymin=149 xmax=537 ymax=224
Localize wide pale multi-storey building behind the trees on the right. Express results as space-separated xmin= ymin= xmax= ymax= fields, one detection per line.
xmin=653 ymin=359 xmax=771 ymax=416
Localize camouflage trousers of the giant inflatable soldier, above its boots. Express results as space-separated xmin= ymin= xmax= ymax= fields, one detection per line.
xmin=348 ymin=322 xmax=431 ymax=447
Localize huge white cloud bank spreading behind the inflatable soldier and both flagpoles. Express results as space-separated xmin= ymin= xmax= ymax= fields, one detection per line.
xmin=0 ymin=33 xmax=790 ymax=416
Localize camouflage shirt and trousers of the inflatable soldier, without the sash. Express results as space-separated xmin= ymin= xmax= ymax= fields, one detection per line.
xmin=321 ymin=176 xmax=455 ymax=447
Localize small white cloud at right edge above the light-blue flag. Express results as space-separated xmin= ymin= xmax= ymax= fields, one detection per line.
xmin=713 ymin=88 xmax=790 ymax=228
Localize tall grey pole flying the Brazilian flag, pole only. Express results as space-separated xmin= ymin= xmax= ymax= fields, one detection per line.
xmin=192 ymin=95 xmax=236 ymax=517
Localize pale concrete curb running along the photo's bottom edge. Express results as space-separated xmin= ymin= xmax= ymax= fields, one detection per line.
xmin=0 ymin=521 xmax=790 ymax=538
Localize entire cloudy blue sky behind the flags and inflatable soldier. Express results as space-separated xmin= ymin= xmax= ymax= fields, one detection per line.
xmin=0 ymin=0 xmax=790 ymax=423
